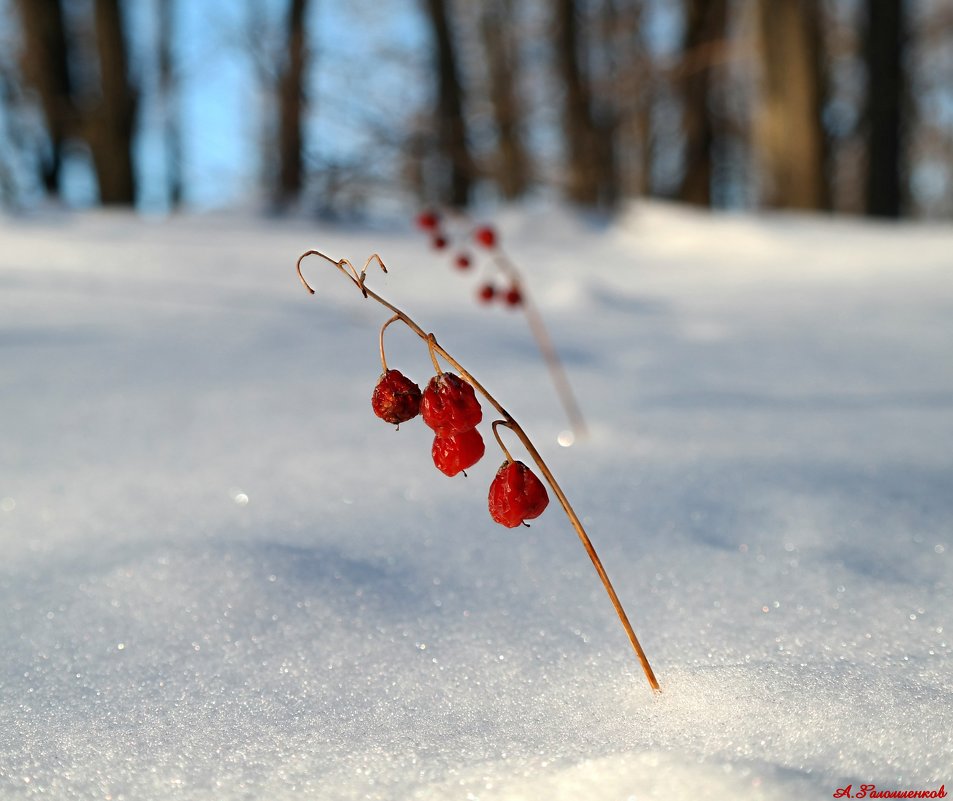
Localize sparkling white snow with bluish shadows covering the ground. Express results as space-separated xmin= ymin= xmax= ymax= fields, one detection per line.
xmin=0 ymin=205 xmax=953 ymax=801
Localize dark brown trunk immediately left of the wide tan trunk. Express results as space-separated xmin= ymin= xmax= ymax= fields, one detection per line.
xmin=678 ymin=0 xmax=728 ymax=206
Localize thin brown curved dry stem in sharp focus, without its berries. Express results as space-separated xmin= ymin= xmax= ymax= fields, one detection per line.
xmin=297 ymin=250 xmax=660 ymax=692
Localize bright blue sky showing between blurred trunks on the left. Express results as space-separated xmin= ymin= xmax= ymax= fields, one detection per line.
xmin=130 ymin=0 xmax=427 ymax=208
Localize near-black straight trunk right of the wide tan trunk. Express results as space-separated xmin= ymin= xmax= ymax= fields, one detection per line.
xmin=864 ymin=0 xmax=906 ymax=217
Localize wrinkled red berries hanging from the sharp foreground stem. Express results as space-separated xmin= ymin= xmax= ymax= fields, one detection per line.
xmin=371 ymin=362 xmax=549 ymax=528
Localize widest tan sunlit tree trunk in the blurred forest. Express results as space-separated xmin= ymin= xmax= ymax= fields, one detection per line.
xmin=756 ymin=0 xmax=831 ymax=209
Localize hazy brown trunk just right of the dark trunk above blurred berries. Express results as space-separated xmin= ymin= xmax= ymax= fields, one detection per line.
xmin=480 ymin=0 xmax=530 ymax=200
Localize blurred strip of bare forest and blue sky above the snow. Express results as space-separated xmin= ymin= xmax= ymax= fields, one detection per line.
xmin=0 ymin=0 xmax=953 ymax=219
